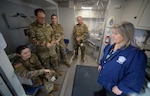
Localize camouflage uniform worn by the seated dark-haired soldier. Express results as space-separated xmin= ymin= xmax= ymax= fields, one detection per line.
xmin=13 ymin=54 xmax=57 ymax=93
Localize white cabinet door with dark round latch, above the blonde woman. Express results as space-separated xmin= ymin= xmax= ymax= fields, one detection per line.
xmin=121 ymin=0 xmax=144 ymax=25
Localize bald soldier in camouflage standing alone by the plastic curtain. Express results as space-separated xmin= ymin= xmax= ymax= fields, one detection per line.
xmin=73 ymin=16 xmax=88 ymax=62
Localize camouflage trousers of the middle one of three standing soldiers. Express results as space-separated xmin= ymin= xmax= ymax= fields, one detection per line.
xmin=56 ymin=41 xmax=67 ymax=62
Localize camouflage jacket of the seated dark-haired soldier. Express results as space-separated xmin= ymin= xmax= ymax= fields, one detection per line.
xmin=13 ymin=54 xmax=44 ymax=85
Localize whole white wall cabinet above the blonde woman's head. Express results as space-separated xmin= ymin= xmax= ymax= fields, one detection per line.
xmin=121 ymin=0 xmax=150 ymax=30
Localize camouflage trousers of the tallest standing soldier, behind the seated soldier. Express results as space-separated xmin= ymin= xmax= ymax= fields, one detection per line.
xmin=37 ymin=46 xmax=58 ymax=70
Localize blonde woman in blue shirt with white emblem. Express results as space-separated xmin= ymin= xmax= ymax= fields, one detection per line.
xmin=94 ymin=21 xmax=147 ymax=96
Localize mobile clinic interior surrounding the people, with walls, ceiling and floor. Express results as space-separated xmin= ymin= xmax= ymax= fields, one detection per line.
xmin=0 ymin=0 xmax=150 ymax=96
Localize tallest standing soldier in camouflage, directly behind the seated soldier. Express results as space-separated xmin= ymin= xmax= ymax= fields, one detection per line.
xmin=28 ymin=8 xmax=62 ymax=76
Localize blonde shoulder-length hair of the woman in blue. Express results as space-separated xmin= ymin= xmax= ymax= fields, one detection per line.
xmin=112 ymin=21 xmax=136 ymax=48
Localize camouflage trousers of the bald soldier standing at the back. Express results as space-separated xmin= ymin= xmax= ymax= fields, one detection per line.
xmin=74 ymin=41 xmax=85 ymax=57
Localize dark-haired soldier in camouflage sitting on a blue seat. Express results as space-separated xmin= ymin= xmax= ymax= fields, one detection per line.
xmin=13 ymin=45 xmax=58 ymax=96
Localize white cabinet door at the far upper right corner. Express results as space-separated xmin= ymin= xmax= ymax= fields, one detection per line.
xmin=138 ymin=0 xmax=150 ymax=29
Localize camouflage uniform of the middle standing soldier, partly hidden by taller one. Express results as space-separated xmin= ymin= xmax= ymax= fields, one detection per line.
xmin=50 ymin=24 xmax=67 ymax=62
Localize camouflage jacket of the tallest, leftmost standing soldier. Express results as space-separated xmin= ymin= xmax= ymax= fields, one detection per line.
xmin=28 ymin=22 xmax=55 ymax=52
